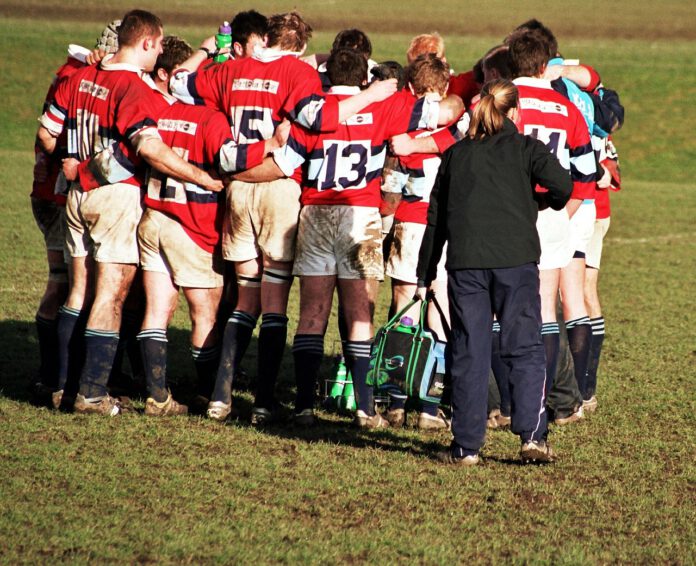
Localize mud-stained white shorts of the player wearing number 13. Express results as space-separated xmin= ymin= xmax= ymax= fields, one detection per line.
xmin=293 ymin=204 xmax=384 ymax=281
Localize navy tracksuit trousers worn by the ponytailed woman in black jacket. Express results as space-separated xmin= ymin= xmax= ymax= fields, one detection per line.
xmin=448 ymin=263 xmax=547 ymax=451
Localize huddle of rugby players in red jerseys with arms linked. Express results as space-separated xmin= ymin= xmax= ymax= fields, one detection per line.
xmin=32 ymin=10 xmax=623 ymax=464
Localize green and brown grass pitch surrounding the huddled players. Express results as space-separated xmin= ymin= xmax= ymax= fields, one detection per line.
xmin=0 ymin=0 xmax=696 ymax=564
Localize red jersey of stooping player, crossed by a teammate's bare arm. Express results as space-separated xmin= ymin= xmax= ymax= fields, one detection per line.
xmin=145 ymin=103 xmax=232 ymax=252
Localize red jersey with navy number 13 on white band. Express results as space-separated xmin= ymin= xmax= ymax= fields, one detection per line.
xmin=274 ymin=90 xmax=432 ymax=208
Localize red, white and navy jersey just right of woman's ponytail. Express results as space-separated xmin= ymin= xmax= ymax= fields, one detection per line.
xmin=513 ymin=77 xmax=597 ymax=199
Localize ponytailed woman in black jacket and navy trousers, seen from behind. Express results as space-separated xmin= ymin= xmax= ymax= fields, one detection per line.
xmin=418 ymin=80 xmax=572 ymax=465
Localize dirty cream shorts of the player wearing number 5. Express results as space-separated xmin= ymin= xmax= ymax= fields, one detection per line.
xmin=222 ymin=179 xmax=302 ymax=261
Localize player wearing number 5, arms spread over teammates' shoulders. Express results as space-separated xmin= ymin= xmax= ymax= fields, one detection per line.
xmin=166 ymin=12 xmax=396 ymax=423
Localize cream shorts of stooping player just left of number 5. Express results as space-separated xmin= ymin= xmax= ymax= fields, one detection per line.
xmin=138 ymin=208 xmax=223 ymax=289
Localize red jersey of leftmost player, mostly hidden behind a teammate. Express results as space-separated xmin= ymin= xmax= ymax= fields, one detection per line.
xmin=31 ymin=56 xmax=85 ymax=206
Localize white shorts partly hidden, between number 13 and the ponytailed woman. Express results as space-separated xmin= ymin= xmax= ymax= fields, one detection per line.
xmin=385 ymin=220 xmax=447 ymax=285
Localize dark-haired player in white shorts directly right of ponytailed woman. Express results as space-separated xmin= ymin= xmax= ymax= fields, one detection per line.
xmin=508 ymin=31 xmax=596 ymax=424
